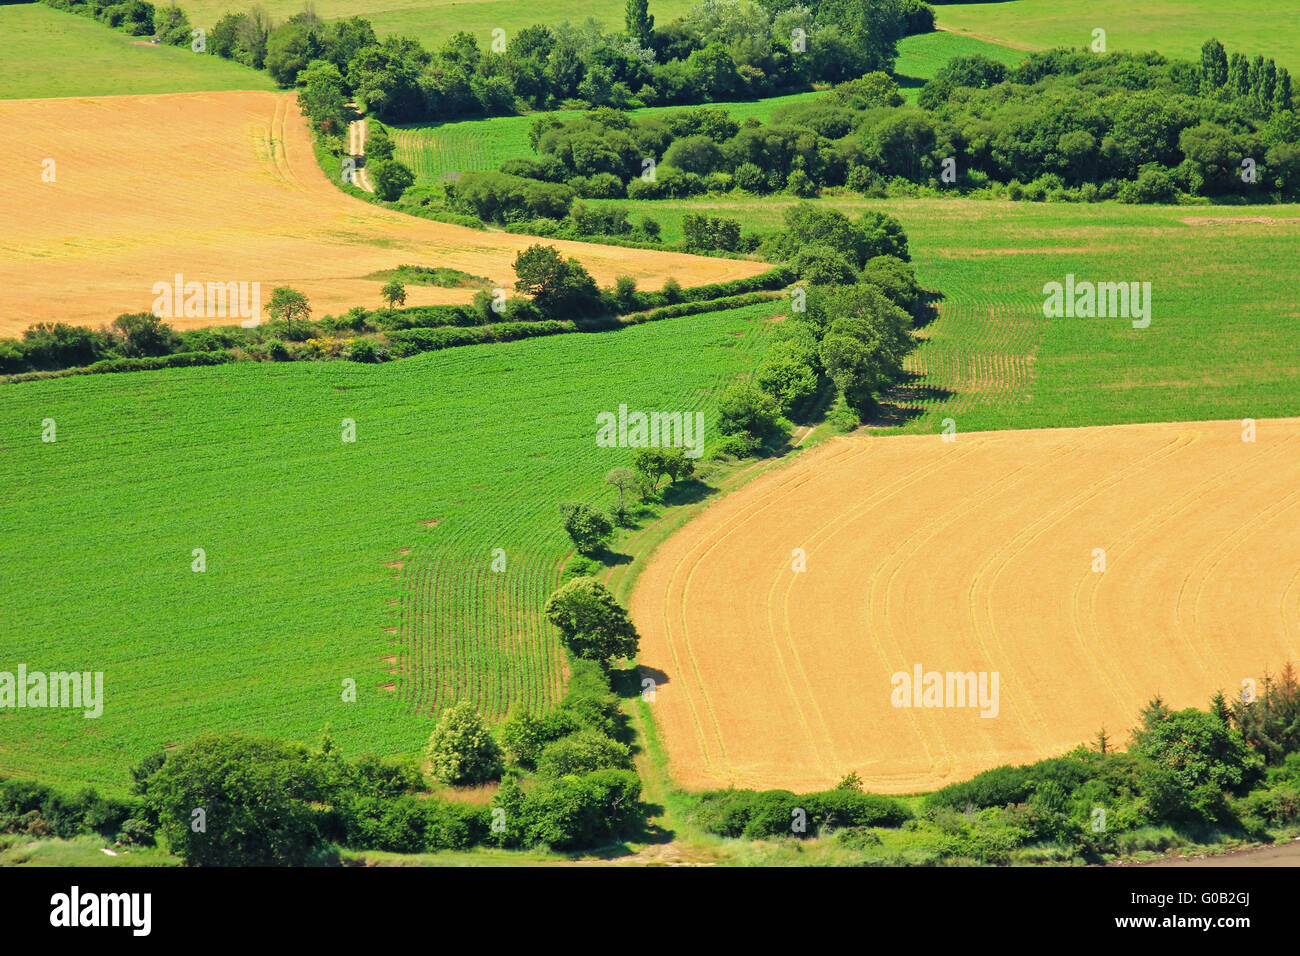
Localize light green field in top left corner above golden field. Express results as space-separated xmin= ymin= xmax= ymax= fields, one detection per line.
xmin=0 ymin=4 xmax=276 ymax=100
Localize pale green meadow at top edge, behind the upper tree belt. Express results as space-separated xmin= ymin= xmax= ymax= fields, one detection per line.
xmin=179 ymin=0 xmax=692 ymax=49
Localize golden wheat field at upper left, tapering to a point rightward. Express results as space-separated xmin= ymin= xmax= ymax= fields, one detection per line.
xmin=0 ymin=92 xmax=768 ymax=334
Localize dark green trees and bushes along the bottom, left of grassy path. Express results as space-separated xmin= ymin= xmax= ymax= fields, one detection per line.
xmin=49 ymin=659 xmax=644 ymax=866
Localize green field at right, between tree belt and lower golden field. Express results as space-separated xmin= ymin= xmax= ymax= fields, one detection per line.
xmin=592 ymin=196 xmax=1300 ymax=432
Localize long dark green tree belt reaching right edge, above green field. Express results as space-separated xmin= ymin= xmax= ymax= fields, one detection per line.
xmin=467 ymin=47 xmax=1300 ymax=208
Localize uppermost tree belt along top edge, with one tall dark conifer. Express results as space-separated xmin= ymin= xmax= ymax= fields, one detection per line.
xmin=208 ymin=0 xmax=933 ymax=122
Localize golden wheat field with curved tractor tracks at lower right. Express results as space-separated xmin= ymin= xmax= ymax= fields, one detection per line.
xmin=632 ymin=419 xmax=1300 ymax=793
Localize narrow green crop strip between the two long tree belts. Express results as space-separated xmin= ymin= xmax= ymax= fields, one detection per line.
xmin=397 ymin=92 xmax=818 ymax=183
